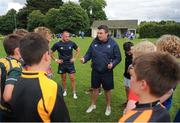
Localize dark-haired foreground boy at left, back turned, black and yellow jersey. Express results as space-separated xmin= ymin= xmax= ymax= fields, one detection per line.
xmin=10 ymin=33 xmax=70 ymax=122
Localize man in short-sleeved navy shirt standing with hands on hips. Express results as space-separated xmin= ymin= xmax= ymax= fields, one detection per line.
xmin=51 ymin=31 xmax=80 ymax=99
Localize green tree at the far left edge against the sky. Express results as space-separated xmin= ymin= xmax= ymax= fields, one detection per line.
xmin=0 ymin=9 xmax=17 ymax=35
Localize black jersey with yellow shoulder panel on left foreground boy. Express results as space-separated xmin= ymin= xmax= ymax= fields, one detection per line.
xmin=10 ymin=71 xmax=70 ymax=122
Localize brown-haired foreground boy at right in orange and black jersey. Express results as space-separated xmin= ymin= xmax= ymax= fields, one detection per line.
xmin=119 ymin=52 xmax=180 ymax=122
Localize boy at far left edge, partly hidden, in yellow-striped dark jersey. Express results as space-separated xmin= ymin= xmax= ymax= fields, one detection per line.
xmin=0 ymin=34 xmax=22 ymax=122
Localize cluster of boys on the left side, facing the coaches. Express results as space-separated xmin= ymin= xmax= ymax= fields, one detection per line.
xmin=0 ymin=27 xmax=70 ymax=122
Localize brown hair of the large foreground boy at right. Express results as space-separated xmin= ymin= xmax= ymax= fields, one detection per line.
xmin=132 ymin=52 xmax=180 ymax=97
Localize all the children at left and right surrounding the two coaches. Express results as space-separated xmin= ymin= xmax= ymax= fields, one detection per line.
xmin=0 ymin=27 xmax=180 ymax=122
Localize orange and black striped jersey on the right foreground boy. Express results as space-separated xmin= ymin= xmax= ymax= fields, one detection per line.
xmin=119 ymin=101 xmax=170 ymax=123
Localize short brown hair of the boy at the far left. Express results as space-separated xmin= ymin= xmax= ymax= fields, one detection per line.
xmin=3 ymin=34 xmax=22 ymax=55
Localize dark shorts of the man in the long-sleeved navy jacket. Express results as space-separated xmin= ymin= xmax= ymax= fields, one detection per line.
xmin=91 ymin=70 xmax=114 ymax=90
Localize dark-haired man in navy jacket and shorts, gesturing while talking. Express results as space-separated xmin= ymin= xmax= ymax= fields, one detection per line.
xmin=81 ymin=25 xmax=121 ymax=116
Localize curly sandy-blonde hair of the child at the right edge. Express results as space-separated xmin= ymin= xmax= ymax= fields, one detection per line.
xmin=156 ymin=35 xmax=180 ymax=58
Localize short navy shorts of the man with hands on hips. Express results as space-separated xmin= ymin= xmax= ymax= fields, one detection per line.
xmin=57 ymin=64 xmax=76 ymax=74
